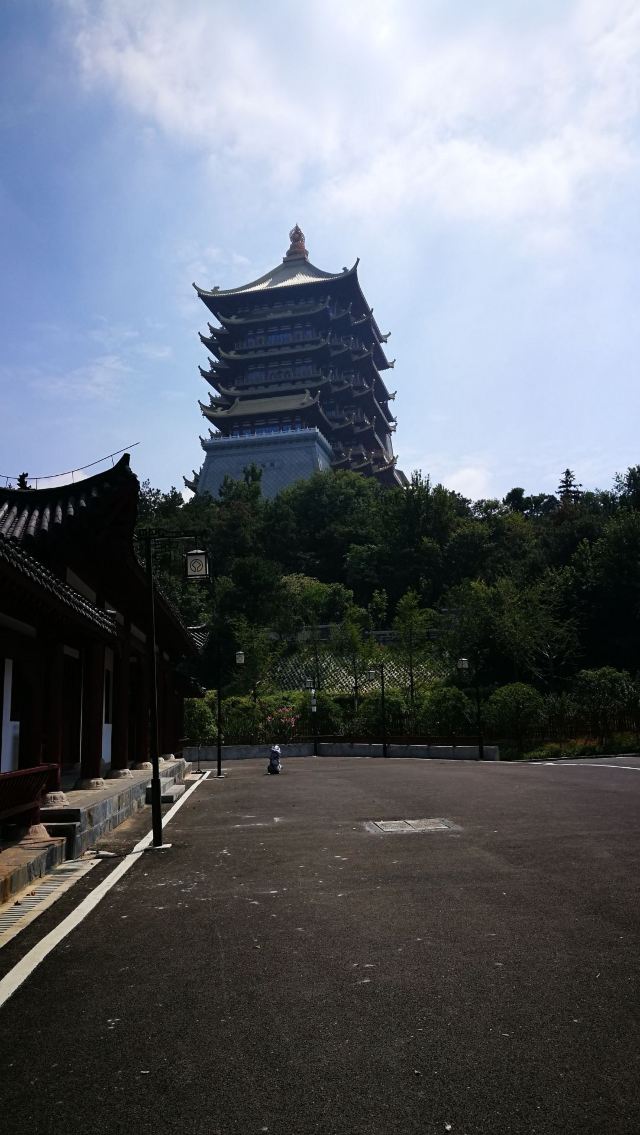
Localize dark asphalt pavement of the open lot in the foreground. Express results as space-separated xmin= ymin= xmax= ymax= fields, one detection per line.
xmin=0 ymin=758 xmax=640 ymax=1135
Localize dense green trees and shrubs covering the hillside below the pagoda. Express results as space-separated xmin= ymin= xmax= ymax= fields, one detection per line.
xmin=140 ymin=466 xmax=640 ymax=743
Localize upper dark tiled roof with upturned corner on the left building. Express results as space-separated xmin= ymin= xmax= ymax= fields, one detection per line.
xmin=0 ymin=453 xmax=137 ymax=543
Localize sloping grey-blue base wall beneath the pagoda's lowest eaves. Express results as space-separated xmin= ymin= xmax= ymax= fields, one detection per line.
xmin=197 ymin=429 xmax=332 ymax=497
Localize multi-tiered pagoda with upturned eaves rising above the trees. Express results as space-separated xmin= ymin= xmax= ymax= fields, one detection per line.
xmin=185 ymin=225 xmax=406 ymax=497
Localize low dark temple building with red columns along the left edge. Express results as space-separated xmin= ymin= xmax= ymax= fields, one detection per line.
xmin=0 ymin=454 xmax=197 ymax=799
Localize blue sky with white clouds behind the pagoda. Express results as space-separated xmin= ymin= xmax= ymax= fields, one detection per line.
xmin=0 ymin=0 xmax=640 ymax=499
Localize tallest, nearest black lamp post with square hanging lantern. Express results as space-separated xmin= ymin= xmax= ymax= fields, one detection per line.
xmin=138 ymin=528 xmax=209 ymax=848
